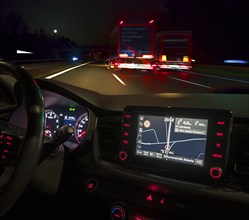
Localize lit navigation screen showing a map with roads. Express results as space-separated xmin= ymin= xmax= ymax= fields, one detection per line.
xmin=136 ymin=115 xmax=208 ymax=167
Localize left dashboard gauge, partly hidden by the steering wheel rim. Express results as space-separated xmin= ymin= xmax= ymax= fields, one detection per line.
xmin=45 ymin=109 xmax=59 ymax=137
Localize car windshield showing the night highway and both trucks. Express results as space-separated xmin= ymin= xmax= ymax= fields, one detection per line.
xmin=0 ymin=0 xmax=249 ymax=95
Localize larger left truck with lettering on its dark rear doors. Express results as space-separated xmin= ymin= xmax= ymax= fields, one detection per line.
xmin=109 ymin=20 xmax=155 ymax=69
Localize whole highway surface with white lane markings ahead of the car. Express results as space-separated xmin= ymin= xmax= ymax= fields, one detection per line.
xmin=22 ymin=61 xmax=249 ymax=94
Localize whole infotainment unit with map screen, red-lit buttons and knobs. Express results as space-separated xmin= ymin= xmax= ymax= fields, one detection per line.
xmin=119 ymin=106 xmax=232 ymax=183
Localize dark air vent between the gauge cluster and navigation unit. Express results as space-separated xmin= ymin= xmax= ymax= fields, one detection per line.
xmin=98 ymin=117 xmax=122 ymax=161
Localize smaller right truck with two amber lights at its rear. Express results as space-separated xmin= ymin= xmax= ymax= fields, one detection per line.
xmin=155 ymin=31 xmax=192 ymax=70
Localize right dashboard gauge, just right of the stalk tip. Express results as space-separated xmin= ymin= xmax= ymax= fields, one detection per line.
xmin=74 ymin=113 xmax=88 ymax=143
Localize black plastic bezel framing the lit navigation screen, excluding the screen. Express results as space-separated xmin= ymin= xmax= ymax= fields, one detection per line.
xmin=123 ymin=106 xmax=232 ymax=179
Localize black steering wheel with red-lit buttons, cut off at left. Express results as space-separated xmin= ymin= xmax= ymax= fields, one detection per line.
xmin=0 ymin=61 xmax=45 ymax=218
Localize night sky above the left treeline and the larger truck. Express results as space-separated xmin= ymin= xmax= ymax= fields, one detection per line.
xmin=0 ymin=0 xmax=165 ymax=45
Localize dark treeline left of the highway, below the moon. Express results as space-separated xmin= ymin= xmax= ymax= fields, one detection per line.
xmin=0 ymin=12 xmax=77 ymax=60
